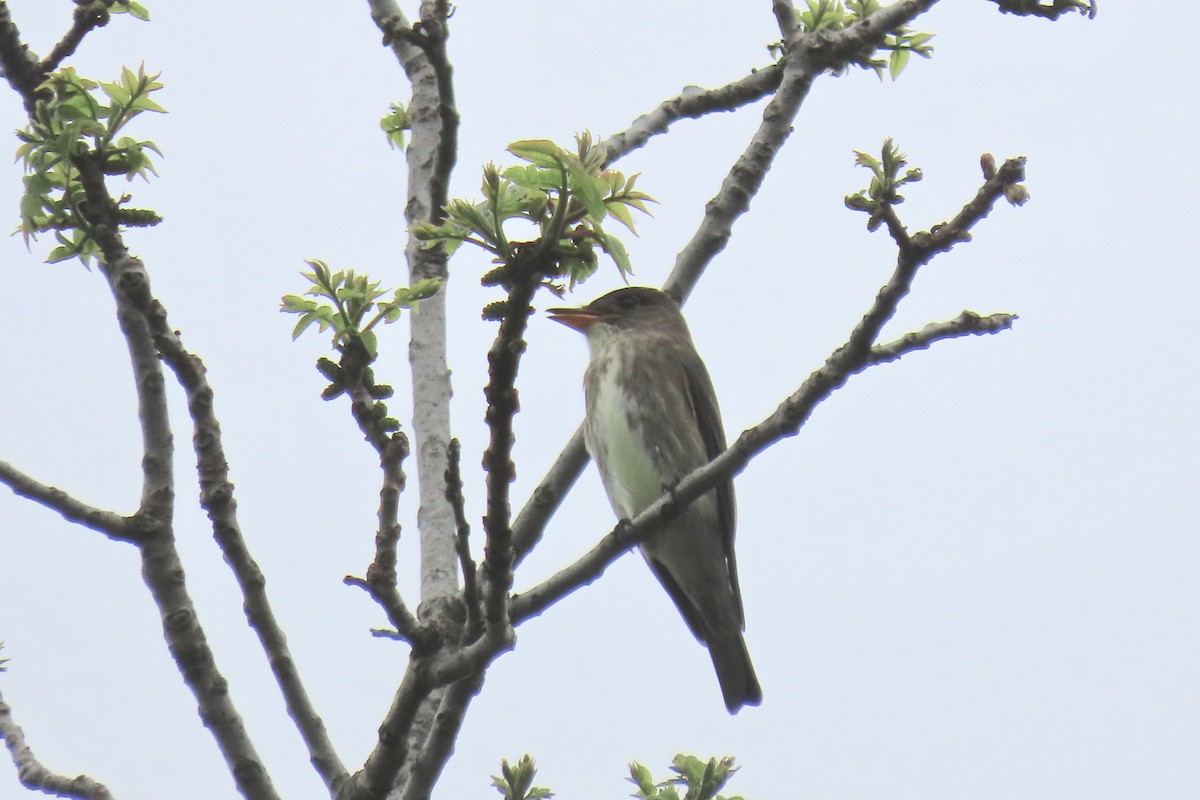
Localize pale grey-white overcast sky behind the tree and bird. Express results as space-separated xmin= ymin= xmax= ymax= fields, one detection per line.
xmin=0 ymin=0 xmax=1200 ymax=800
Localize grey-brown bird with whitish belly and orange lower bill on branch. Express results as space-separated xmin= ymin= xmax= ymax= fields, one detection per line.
xmin=548 ymin=287 xmax=762 ymax=712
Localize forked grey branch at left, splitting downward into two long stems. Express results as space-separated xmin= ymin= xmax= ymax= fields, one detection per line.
xmin=66 ymin=145 xmax=321 ymax=800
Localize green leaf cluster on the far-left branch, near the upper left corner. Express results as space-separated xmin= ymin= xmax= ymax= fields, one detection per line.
xmin=17 ymin=65 xmax=166 ymax=264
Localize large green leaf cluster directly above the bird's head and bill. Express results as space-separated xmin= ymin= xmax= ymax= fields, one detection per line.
xmin=413 ymin=132 xmax=654 ymax=291
